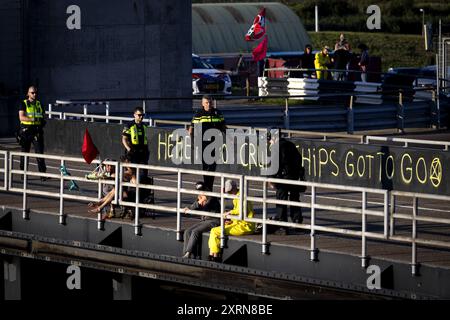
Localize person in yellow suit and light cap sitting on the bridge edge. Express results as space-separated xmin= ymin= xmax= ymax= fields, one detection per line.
xmin=208 ymin=180 xmax=256 ymax=261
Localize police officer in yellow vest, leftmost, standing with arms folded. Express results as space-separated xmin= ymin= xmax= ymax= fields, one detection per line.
xmin=18 ymin=86 xmax=47 ymax=181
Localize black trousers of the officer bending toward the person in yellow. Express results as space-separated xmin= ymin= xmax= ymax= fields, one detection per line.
xmin=275 ymin=184 xmax=303 ymax=223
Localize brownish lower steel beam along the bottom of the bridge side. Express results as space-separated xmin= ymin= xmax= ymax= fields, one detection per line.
xmin=0 ymin=236 xmax=386 ymax=300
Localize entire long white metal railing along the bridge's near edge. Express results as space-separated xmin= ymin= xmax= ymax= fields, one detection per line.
xmin=1 ymin=151 xmax=450 ymax=275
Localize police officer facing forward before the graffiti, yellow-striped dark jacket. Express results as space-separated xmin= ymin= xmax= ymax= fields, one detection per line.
xmin=189 ymin=95 xmax=226 ymax=190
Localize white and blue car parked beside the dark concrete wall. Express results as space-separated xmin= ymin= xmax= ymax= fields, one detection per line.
xmin=192 ymin=54 xmax=231 ymax=95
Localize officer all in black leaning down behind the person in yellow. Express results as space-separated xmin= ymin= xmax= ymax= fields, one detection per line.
xmin=267 ymin=129 xmax=306 ymax=235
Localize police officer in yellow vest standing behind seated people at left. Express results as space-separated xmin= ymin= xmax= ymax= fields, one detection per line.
xmin=122 ymin=107 xmax=150 ymax=176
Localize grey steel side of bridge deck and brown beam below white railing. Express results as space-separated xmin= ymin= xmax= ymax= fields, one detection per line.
xmin=0 ymin=211 xmax=449 ymax=299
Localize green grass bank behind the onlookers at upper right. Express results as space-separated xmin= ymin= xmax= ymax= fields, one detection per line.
xmin=308 ymin=31 xmax=435 ymax=72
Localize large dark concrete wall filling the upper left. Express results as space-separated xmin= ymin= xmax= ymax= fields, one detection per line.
xmin=0 ymin=0 xmax=192 ymax=110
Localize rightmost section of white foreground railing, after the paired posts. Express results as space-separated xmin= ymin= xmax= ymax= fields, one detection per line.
xmin=389 ymin=191 xmax=450 ymax=275
